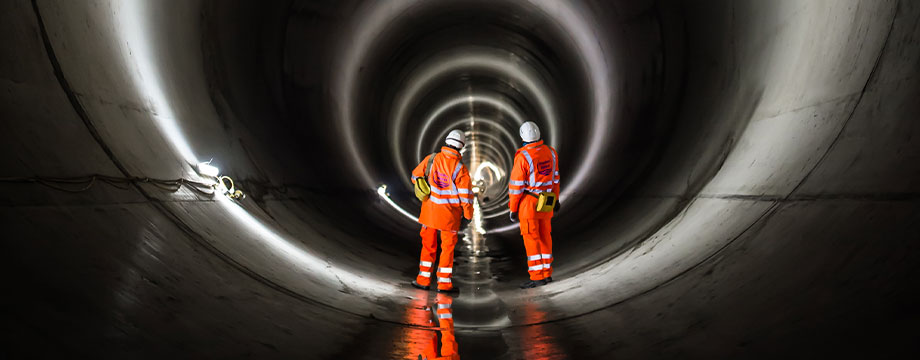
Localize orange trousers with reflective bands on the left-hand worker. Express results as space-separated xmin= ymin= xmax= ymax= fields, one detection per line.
xmin=415 ymin=226 xmax=457 ymax=290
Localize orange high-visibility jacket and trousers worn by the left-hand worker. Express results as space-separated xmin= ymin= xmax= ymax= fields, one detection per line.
xmin=412 ymin=146 xmax=473 ymax=290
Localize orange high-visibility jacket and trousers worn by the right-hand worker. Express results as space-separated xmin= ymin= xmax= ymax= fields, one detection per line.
xmin=508 ymin=140 xmax=559 ymax=280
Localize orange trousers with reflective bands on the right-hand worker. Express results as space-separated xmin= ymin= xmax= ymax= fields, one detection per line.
xmin=521 ymin=219 xmax=553 ymax=280
